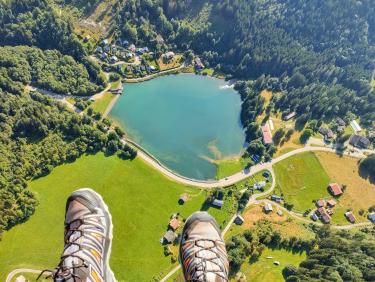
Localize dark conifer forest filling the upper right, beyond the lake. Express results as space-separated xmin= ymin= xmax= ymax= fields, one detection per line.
xmin=113 ymin=0 xmax=375 ymax=139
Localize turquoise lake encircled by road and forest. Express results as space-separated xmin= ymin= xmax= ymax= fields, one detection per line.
xmin=110 ymin=74 xmax=245 ymax=180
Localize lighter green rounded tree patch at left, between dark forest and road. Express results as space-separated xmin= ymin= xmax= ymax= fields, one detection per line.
xmin=0 ymin=46 xmax=104 ymax=95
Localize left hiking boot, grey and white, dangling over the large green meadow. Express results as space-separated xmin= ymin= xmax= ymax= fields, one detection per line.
xmin=39 ymin=189 xmax=116 ymax=282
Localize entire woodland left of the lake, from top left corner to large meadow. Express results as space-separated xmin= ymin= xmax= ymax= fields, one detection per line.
xmin=0 ymin=0 xmax=137 ymax=236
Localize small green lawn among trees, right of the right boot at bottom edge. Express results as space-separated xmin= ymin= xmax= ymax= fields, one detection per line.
xmin=235 ymin=248 xmax=306 ymax=282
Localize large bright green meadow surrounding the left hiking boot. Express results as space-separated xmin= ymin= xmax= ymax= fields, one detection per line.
xmin=0 ymin=154 xmax=232 ymax=281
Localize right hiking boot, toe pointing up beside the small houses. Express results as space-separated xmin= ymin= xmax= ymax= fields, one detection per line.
xmin=180 ymin=212 xmax=229 ymax=282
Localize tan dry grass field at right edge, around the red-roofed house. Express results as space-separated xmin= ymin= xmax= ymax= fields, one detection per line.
xmin=316 ymin=152 xmax=375 ymax=224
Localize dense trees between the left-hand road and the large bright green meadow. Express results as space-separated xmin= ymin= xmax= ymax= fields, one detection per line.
xmin=0 ymin=89 xmax=136 ymax=233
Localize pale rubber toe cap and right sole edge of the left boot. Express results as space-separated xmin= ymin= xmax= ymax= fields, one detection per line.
xmin=67 ymin=188 xmax=117 ymax=282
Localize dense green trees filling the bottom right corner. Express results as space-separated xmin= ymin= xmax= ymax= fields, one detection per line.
xmin=283 ymin=230 xmax=375 ymax=282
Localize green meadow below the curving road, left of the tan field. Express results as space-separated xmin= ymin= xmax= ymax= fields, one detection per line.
xmin=274 ymin=152 xmax=330 ymax=212
